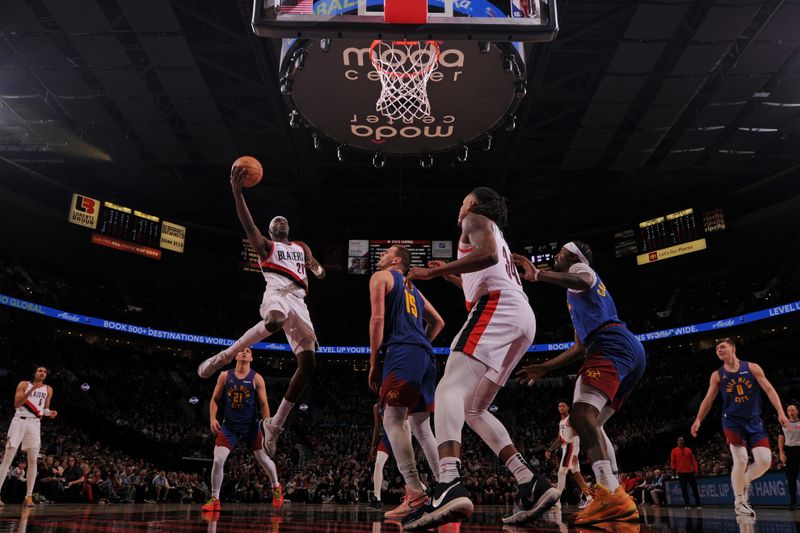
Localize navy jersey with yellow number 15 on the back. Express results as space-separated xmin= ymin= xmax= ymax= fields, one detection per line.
xmin=383 ymin=270 xmax=433 ymax=353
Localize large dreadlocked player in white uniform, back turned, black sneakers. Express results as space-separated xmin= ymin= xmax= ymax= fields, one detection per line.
xmin=404 ymin=187 xmax=558 ymax=529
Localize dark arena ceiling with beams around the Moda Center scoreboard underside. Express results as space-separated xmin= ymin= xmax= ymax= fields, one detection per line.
xmin=0 ymin=0 xmax=800 ymax=239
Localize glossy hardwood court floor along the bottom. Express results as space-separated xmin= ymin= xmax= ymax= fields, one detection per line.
xmin=0 ymin=504 xmax=800 ymax=533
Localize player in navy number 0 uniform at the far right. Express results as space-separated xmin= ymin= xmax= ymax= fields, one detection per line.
xmin=692 ymin=339 xmax=789 ymax=517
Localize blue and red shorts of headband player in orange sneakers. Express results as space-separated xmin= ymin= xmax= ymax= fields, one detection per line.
xmin=578 ymin=325 xmax=647 ymax=411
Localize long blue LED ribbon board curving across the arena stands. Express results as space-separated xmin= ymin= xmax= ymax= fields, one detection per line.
xmin=0 ymin=294 xmax=800 ymax=355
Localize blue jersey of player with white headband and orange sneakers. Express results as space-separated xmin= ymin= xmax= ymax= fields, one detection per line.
xmin=567 ymin=263 xmax=622 ymax=344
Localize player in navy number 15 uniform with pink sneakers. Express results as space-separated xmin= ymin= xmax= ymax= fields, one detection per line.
xmin=369 ymin=245 xmax=444 ymax=520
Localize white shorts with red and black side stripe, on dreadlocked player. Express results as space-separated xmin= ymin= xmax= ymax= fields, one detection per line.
xmin=450 ymin=291 xmax=536 ymax=386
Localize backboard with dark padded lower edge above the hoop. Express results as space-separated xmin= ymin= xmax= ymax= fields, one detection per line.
xmin=252 ymin=0 xmax=558 ymax=42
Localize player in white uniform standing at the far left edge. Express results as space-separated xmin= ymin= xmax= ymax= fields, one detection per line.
xmin=0 ymin=366 xmax=58 ymax=507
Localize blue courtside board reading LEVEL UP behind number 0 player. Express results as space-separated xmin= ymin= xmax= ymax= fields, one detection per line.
xmin=664 ymin=472 xmax=800 ymax=508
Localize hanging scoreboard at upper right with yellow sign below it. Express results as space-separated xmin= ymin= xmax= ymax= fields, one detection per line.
xmin=614 ymin=207 xmax=725 ymax=265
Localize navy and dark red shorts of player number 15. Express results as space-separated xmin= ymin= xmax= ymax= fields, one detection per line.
xmin=380 ymin=344 xmax=436 ymax=413
